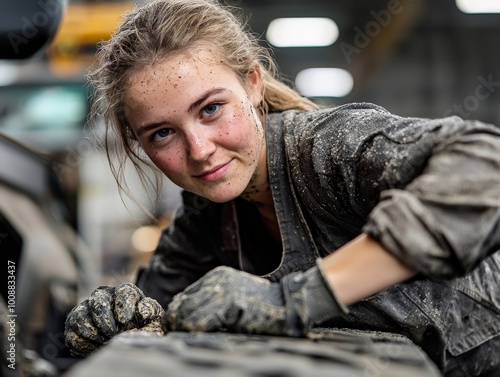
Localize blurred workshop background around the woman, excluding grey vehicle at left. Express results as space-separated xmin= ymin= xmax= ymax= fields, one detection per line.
xmin=0 ymin=0 xmax=500 ymax=279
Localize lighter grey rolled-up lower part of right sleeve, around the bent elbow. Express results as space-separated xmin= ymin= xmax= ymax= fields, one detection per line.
xmin=364 ymin=120 xmax=500 ymax=279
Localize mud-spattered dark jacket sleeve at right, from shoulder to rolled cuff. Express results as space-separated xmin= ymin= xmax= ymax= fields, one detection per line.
xmin=298 ymin=104 xmax=500 ymax=279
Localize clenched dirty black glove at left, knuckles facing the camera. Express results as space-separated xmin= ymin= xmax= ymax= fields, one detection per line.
xmin=64 ymin=283 xmax=164 ymax=356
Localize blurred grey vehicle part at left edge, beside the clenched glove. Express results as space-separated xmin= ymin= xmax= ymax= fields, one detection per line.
xmin=0 ymin=134 xmax=97 ymax=371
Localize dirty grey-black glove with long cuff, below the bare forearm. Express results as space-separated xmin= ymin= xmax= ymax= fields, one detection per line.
xmin=162 ymin=259 xmax=347 ymax=337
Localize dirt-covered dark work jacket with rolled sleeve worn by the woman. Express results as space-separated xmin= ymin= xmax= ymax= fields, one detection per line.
xmin=138 ymin=104 xmax=500 ymax=376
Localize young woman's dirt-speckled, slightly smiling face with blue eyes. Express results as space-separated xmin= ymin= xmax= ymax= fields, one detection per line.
xmin=125 ymin=50 xmax=267 ymax=203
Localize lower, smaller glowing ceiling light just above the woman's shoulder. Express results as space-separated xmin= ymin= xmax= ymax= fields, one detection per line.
xmin=295 ymin=68 xmax=354 ymax=97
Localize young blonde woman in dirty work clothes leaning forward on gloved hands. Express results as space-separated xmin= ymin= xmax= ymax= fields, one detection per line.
xmin=66 ymin=0 xmax=500 ymax=376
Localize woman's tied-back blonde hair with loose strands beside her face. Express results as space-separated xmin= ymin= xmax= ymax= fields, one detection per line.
xmin=87 ymin=0 xmax=317 ymax=207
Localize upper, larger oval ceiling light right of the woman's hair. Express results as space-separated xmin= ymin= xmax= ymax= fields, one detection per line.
xmin=266 ymin=17 xmax=339 ymax=47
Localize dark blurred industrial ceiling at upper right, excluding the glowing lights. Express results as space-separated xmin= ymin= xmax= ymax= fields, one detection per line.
xmin=237 ymin=0 xmax=500 ymax=125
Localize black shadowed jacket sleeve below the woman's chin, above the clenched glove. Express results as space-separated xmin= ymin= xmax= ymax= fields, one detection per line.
xmin=136 ymin=192 xmax=221 ymax=307
